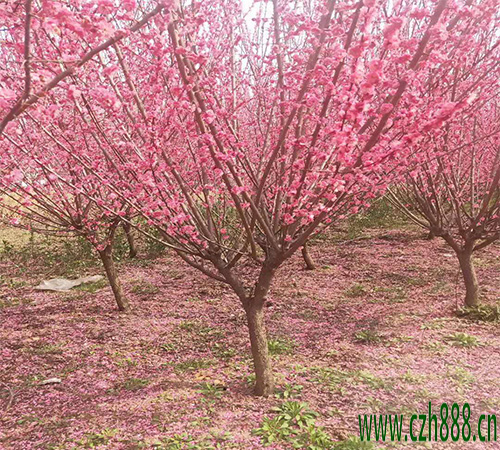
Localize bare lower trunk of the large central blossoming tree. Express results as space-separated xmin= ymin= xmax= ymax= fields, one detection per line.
xmin=246 ymin=302 xmax=274 ymax=397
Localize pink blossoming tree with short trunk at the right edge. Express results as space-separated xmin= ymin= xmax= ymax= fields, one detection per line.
xmin=390 ymin=103 xmax=500 ymax=306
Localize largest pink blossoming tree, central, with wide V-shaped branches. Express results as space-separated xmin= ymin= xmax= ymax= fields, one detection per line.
xmin=4 ymin=0 xmax=497 ymax=395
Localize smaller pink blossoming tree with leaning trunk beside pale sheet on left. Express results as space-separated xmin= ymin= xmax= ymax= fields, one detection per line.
xmin=0 ymin=112 xmax=135 ymax=311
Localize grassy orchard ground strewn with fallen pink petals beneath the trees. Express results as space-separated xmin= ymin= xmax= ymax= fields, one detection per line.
xmin=0 ymin=230 xmax=500 ymax=450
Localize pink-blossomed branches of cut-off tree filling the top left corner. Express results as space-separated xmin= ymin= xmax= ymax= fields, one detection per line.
xmin=0 ymin=0 xmax=165 ymax=134
